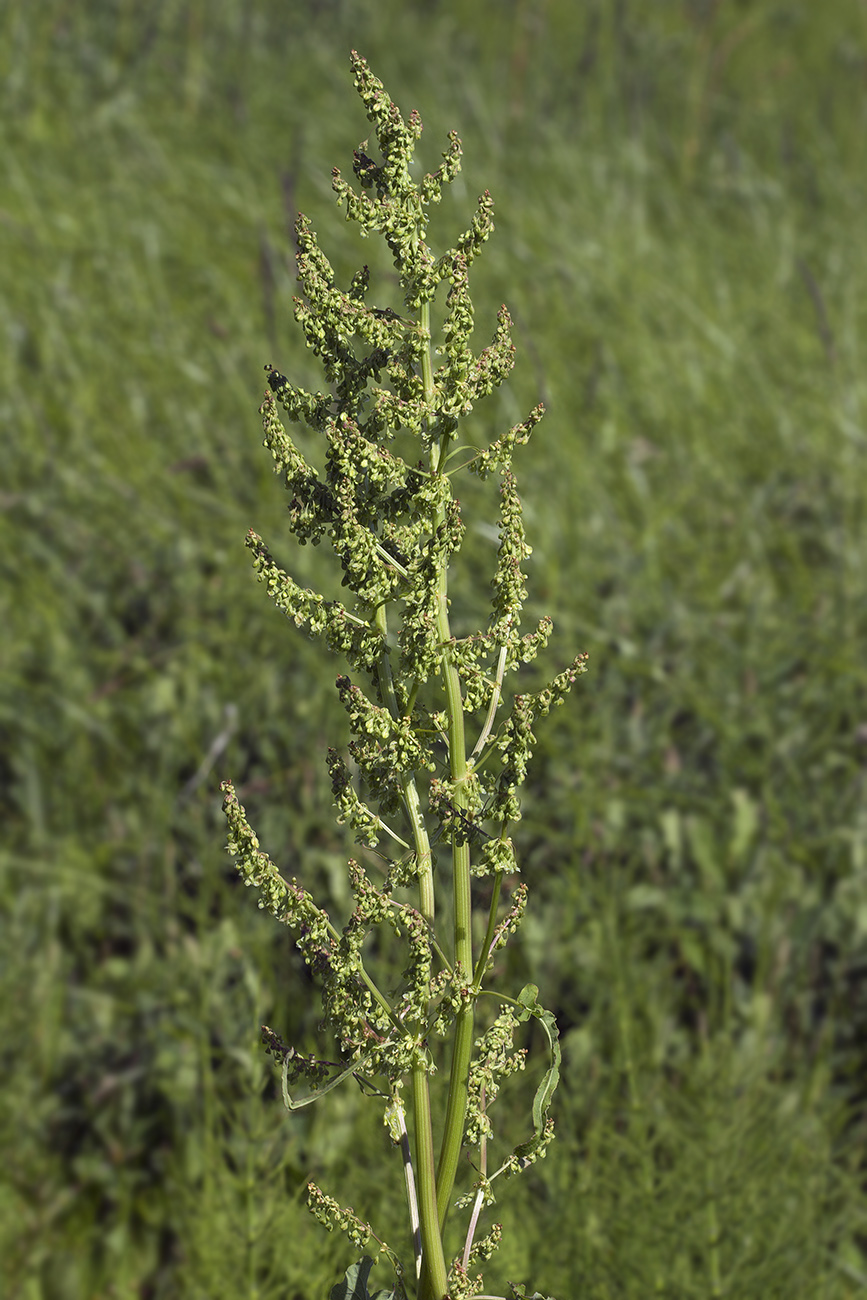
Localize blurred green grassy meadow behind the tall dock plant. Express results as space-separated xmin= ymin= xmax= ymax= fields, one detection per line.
xmin=0 ymin=0 xmax=867 ymax=1300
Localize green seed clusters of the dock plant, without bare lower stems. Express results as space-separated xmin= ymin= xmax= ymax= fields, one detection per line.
xmin=224 ymin=55 xmax=586 ymax=1297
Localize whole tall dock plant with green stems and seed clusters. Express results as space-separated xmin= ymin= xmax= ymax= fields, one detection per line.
xmin=224 ymin=53 xmax=585 ymax=1300
